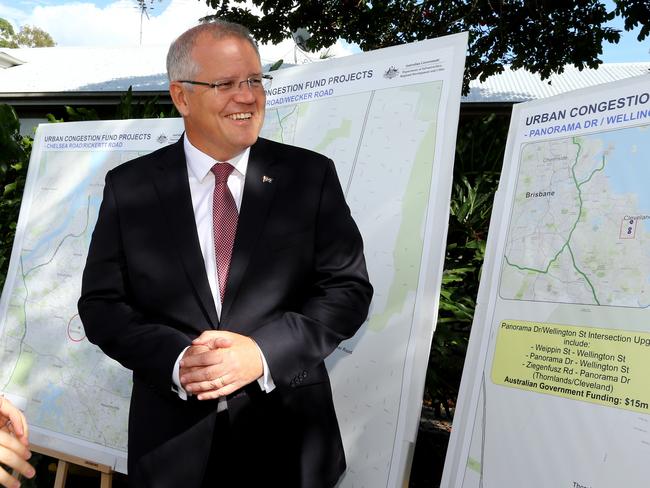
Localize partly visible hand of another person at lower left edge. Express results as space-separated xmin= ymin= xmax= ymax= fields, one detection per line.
xmin=0 ymin=395 xmax=35 ymax=488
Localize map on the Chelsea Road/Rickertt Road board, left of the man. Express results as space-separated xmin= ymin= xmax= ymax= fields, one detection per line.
xmin=0 ymin=150 xmax=147 ymax=466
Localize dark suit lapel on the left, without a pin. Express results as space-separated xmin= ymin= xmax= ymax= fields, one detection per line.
xmin=153 ymin=137 xmax=219 ymax=328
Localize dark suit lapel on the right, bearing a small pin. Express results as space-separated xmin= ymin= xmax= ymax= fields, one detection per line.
xmin=221 ymin=139 xmax=280 ymax=320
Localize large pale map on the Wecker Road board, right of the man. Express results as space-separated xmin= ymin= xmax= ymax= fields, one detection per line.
xmin=262 ymin=82 xmax=442 ymax=486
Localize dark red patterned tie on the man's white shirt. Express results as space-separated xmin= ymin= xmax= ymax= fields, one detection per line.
xmin=211 ymin=163 xmax=238 ymax=303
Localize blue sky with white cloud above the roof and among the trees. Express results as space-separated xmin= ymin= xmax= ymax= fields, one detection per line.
xmin=0 ymin=0 xmax=650 ymax=63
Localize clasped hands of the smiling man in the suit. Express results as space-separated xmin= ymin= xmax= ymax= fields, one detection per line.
xmin=180 ymin=330 xmax=264 ymax=400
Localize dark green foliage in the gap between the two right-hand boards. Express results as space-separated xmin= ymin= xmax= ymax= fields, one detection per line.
xmin=425 ymin=114 xmax=508 ymax=417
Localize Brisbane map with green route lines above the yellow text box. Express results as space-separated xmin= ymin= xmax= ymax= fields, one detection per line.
xmin=500 ymin=125 xmax=650 ymax=308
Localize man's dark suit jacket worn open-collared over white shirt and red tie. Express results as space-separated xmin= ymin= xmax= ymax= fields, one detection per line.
xmin=79 ymin=139 xmax=372 ymax=488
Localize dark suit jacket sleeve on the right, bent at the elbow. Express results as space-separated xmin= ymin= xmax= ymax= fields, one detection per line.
xmin=252 ymin=161 xmax=373 ymax=386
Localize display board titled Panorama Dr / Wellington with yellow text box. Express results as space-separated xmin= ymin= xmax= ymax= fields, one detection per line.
xmin=442 ymin=76 xmax=650 ymax=488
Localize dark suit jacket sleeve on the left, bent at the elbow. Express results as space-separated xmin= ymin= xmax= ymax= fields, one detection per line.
xmin=78 ymin=173 xmax=190 ymax=388
